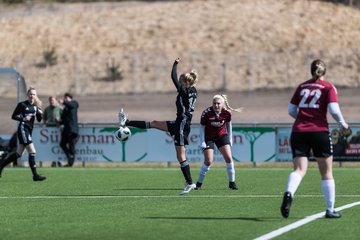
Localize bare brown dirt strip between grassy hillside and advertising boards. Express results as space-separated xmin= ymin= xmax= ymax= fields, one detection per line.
xmin=0 ymin=88 xmax=360 ymax=134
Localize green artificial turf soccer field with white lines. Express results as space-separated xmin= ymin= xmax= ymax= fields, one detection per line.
xmin=0 ymin=167 xmax=360 ymax=240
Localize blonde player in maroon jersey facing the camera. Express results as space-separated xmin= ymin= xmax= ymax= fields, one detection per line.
xmin=195 ymin=95 xmax=241 ymax=190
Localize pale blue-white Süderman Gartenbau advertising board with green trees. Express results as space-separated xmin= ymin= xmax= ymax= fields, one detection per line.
xmin=33 ymin=127 xmax=275 ymax=162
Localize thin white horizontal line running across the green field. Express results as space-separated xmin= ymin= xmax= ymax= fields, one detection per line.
xmin=0 ymin=193 xmax=360 ymax=200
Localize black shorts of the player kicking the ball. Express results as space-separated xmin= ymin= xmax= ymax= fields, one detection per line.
xmin=166 ymin=120 xmax=190 ymax=146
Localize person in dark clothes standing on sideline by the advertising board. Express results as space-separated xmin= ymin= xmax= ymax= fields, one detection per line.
xmin=60 ymin=93 xmax=79 ymax=167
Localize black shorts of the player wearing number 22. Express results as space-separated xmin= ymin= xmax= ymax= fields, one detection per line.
xmin=290 ymin=132 xmax=333 ymax=158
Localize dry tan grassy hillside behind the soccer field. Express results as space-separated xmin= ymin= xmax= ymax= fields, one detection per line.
xmin=0 ymin=0 xmax=360 ymax=96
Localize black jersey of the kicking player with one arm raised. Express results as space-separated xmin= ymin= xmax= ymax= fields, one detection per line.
xmin=171 ymin=62 xmax=197 ymax=122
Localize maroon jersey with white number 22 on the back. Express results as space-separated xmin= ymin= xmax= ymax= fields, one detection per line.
xmin=290 ymin=79 xmax=338 ymax=132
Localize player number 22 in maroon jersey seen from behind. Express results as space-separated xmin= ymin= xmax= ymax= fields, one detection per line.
xmin=280 ymin=59 xmax=349 ymax=218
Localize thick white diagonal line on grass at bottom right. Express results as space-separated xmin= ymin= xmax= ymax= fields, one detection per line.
xmin=254 ymin=202 xmax=360 ymax=240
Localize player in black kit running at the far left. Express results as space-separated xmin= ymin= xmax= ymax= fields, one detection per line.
xmin=0 ymin=87 xmax=46 ymax=181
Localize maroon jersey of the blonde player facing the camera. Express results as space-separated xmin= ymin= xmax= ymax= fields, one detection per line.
xmin=200 ymin=107 xmax=231 ymax=139
